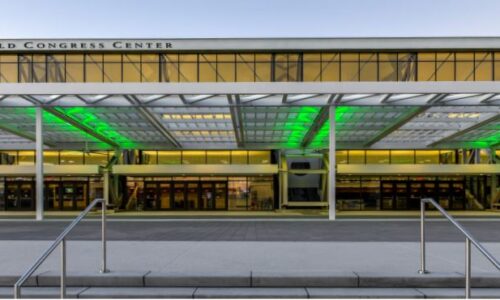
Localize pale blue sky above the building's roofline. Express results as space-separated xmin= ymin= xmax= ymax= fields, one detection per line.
xmin=0 ymin=0 xmax=500 ymax=38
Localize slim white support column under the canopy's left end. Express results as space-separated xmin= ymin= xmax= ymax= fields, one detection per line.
xmin=35 ymin=107 xmax=43 ymax=221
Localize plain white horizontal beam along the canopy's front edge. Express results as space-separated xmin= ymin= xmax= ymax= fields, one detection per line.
xmin=0 ymin=81 xmax=500 ymax=95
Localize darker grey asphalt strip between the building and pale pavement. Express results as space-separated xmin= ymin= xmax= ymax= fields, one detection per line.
xmin=0 ymin=220 xmax=500 ymax=242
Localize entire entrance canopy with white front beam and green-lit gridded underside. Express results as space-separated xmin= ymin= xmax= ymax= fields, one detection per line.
xmin=0 ymin=82 xmax=500 ymax=149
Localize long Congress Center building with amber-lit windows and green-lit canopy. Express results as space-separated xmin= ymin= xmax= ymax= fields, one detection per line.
xmin=0 ymin=38 xmax=500 ymax=215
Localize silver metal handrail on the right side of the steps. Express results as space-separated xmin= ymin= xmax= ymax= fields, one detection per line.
xmin=418 ymin=198 xmax=500 ymax=299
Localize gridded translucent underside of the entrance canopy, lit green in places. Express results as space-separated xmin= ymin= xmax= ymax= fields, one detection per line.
xmin=0 ymin=105 xmax=500 ymax=150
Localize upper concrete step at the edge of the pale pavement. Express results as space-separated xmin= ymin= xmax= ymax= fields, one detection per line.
xmin=0 ymin=270 xmax=500 ymax=288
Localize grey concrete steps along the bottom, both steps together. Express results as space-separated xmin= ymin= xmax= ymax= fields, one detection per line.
xmin=5 ymin=270 xmax=500 ymax=299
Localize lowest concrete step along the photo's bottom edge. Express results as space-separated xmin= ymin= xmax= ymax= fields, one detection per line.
xmin=0 ymin=287 xmax=500 ymax=299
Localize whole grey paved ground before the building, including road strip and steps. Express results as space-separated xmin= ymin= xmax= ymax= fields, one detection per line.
xmin=0 ymin=220 xmax=500 ymax=298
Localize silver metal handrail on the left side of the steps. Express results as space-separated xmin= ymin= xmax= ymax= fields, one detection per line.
xmin=14 ymin=198 xmax=109 ymax=299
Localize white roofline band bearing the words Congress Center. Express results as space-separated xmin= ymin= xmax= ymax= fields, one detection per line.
xmin=0 ymin=37 xmax=500 ymax=53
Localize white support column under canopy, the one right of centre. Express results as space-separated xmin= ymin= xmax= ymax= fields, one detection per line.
xmin=328 ymin=106 xmax=337 ymax=220
